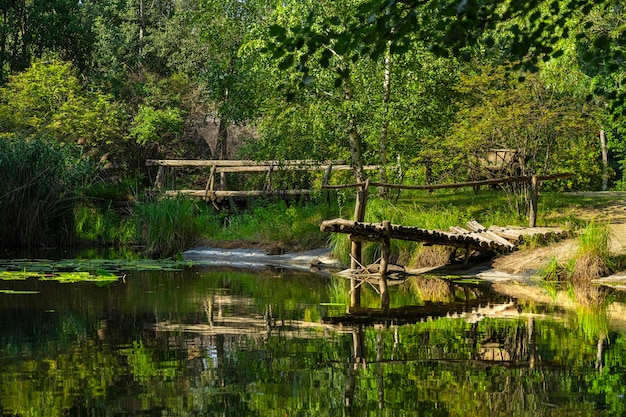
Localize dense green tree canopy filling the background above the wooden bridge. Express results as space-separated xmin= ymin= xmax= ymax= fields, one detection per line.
xmin=0 ymin=0 xmax=626 ymax=188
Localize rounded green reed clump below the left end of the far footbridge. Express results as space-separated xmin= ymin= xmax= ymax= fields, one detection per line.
xmin=133 ymin=197 xmax=220 ymax=257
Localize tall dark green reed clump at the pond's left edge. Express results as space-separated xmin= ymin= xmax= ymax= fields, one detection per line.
xmin=0 ymin=137 xmax=94 ymax=246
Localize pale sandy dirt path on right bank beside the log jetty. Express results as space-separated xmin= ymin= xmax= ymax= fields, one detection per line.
xmin=493 ymin=197 xmax=626 ymax=274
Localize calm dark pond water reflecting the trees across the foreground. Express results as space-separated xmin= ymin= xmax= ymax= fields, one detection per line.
xmin=0 ymin=260 xmax=626 ymax=417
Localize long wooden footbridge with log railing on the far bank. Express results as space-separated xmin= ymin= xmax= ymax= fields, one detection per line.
xmin=146 ymin=159 xmax=379 ymax=202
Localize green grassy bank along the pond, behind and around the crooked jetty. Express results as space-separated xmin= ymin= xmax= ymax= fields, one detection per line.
xmin=76 ymin=190 xmax=617 ymax=265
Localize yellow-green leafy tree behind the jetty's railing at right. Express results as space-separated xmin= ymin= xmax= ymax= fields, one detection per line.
xmin=442 ymin=67 xmax=601 ymax=189
